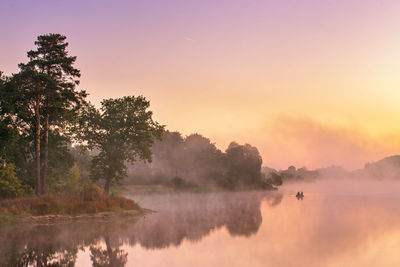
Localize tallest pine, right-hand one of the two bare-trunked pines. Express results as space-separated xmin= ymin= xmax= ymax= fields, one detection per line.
xmin=20 ymin=33 xmax=87 ymax=194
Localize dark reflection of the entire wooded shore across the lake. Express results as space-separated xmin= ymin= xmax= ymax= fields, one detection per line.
xmin=0 ymin=192 xmax=282 ymax=266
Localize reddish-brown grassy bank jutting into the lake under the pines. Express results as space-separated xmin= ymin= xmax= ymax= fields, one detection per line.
xmin=0 ymin=195 xmax=143 ymax=226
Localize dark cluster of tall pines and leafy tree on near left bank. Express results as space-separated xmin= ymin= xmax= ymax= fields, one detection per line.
xmin=0 ymin=34 xmax=164 ymax=198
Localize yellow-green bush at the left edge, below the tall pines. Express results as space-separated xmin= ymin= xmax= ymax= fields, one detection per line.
xmin=0 ymin=163 xmax=32 ymax=199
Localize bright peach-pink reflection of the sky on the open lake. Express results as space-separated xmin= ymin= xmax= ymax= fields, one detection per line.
xmin=114 ymin=186 xmax=400 ymax=266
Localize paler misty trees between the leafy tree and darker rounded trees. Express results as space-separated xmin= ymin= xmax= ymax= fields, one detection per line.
xmin=129 ymin=131 xmax=224 ymax=184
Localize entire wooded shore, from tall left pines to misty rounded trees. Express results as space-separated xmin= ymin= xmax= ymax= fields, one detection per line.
xmin=0 ymin=34 xmax=278 ymax=201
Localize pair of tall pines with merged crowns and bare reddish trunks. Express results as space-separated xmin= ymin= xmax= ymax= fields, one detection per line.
xmin=1 ymin=34 xmax=86 ymax=195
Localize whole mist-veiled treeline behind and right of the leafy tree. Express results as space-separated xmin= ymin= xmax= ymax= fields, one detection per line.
xmin=124 ymin=131 xmax=270 ymax=190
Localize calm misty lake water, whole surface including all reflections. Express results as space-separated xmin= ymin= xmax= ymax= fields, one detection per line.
xmin=0 ymin=181 xmax=400 ymax=266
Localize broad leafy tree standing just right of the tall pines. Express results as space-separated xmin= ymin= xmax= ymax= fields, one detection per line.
xmin=79 ymin=96 xmax=164 ymax=194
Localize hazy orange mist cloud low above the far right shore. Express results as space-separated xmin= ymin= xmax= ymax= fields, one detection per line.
xmin=257 ymin=116 xmax=400 ymax=169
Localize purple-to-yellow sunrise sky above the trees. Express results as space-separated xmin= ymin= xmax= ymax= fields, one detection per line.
xmin=0 ymin=0 xmax=400 ymax=170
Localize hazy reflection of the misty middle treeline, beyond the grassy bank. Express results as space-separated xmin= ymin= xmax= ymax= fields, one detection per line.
xmin=127 ymin=192 xmax=282 ymax=248
